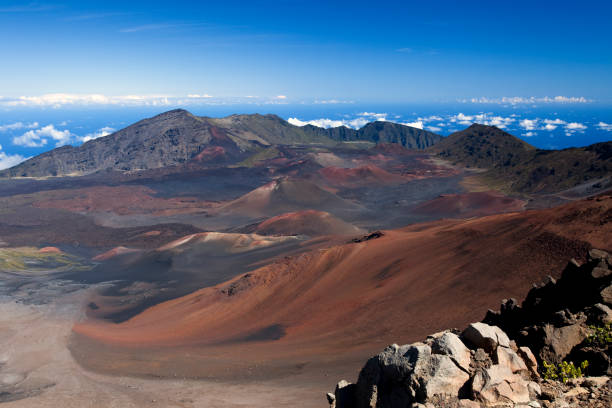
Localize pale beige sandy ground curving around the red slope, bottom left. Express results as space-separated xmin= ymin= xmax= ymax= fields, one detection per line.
xmin=0 ymin=290 xmax=326 ymax=408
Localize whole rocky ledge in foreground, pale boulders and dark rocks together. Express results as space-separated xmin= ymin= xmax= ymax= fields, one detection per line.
xmin=327 ymin=249 xmax=612 ymax=408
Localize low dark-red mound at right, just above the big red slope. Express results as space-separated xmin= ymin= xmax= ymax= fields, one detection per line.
xmin=414 ymin=191 xmax=527 ymax=218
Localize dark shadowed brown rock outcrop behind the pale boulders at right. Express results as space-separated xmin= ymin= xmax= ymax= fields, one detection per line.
xmin=484 ymin=249 xmax=612 ymax=375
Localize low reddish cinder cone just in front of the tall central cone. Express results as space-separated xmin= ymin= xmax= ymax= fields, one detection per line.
xmin=253 ymin=210 xmax=363 ymax=237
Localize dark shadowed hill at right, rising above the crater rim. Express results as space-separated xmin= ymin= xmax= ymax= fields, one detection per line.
xmin=428 ymin=124 xmax=612 ymax=195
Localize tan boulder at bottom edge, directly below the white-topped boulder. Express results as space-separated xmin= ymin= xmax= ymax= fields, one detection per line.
xmin=472 ymin=364 xmax=530 ymax=406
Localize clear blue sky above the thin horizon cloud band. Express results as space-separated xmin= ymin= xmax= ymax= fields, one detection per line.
xmin=0 ymin=0 xmax=612 ymax=102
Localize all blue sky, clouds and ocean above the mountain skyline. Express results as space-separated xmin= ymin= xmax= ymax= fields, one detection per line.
xmin=0 ymin=0 xmax=612 ymax=168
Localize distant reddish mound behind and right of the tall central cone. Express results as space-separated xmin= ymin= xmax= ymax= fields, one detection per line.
xmin=319 ymin=164 xmax=409 ymax=188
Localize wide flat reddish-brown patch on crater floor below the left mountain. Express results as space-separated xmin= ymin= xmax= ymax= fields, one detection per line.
xmin=33 ymin=186 xmax=211 ymax=215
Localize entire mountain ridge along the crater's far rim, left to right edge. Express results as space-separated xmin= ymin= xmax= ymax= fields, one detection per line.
xmin=0 ymin=109 xmax=612 ymax=196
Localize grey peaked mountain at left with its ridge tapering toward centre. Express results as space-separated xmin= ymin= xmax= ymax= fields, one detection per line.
xmin=0 ymin=109 xmax=442 ymax=177
